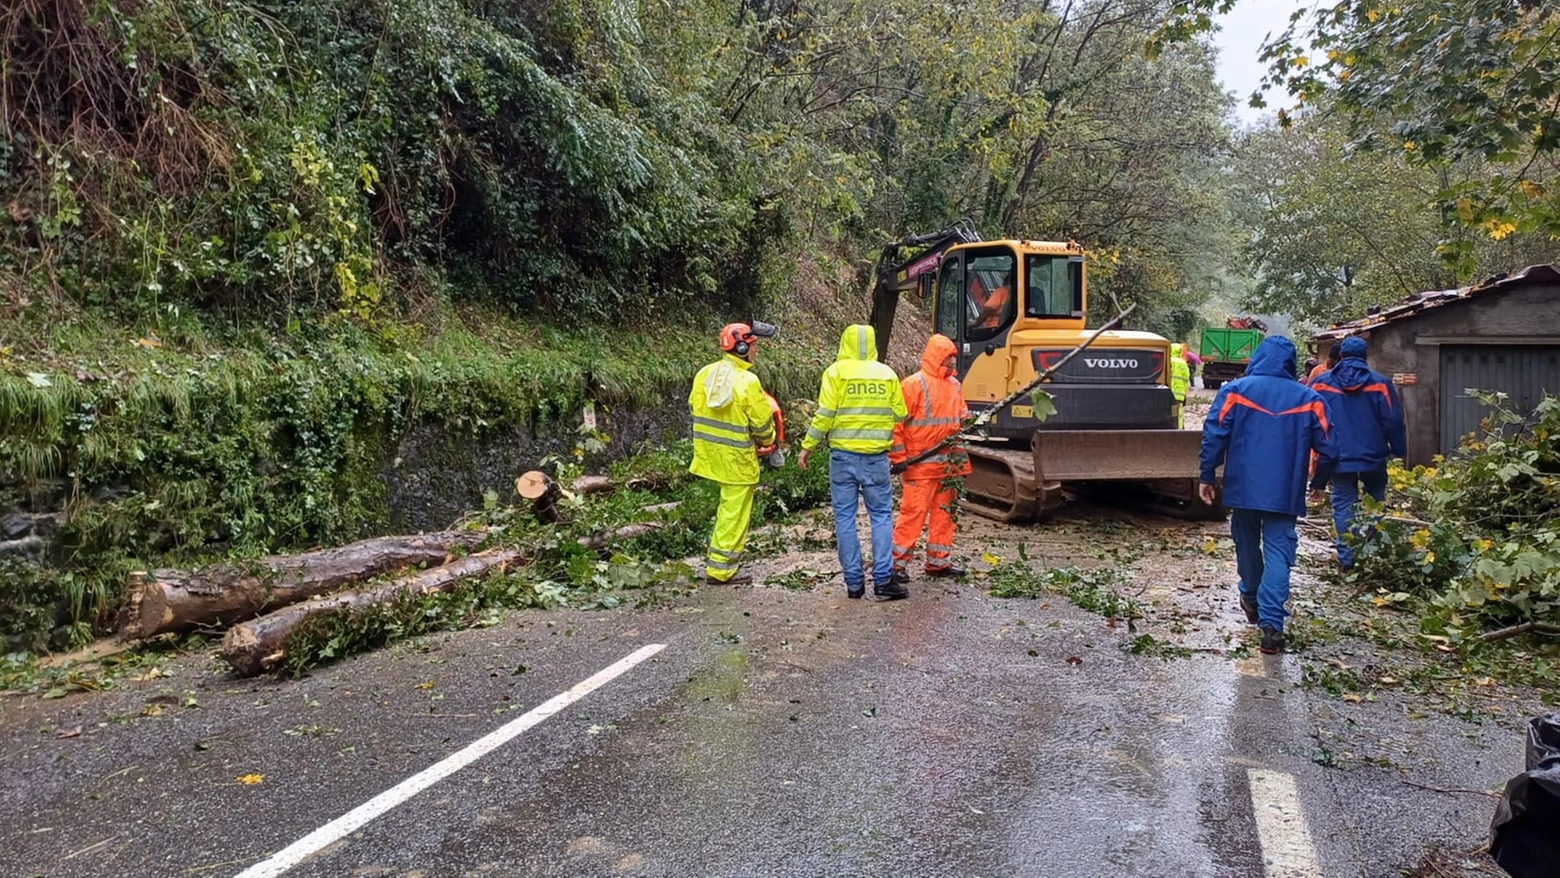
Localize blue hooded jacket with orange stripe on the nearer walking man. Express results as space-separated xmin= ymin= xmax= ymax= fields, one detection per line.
xmin=1201 ymin=335 xmax=1337 ymax=516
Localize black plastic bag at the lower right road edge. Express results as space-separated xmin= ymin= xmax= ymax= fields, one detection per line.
xmin=1490 ymin=713 xmax=1560 ymax=878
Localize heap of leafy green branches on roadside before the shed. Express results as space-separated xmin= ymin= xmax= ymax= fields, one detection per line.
xmin=1351 ymin=396 xmax=1560 ymax=639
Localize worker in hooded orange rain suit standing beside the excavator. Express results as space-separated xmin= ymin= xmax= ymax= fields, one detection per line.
xmin=888 ymin=335 xmax=970 ymax=583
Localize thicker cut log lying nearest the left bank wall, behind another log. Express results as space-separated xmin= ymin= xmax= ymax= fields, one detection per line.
xmin=119 ymin=530 xmax=487 ymax=639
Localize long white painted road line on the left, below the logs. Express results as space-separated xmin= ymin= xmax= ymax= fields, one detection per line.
xmin=234 ymin=643 xmax=666 ymax=878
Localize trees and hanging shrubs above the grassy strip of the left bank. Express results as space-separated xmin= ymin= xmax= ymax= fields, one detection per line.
xmin=0 ymin=0 xmax=1226 ymax=326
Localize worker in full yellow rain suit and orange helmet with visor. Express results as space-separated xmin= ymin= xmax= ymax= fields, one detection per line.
xmin=688 ymin=321 xmax=775 ymax=585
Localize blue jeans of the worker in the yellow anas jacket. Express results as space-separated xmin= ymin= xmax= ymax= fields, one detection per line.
xmin=828 ymin=449 xmax=894 ymax=591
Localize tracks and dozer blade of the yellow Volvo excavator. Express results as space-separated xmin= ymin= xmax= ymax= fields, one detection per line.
xmin=964 ymin=430 xmax=1228 ymax=524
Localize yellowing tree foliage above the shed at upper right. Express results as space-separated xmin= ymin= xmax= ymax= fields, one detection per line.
xmin=1148 ymin=0 xmax=1560 ymax=310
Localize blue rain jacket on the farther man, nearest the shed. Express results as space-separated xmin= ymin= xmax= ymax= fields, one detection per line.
xmin=1310 ymin=338 xmax=1407 ymax=473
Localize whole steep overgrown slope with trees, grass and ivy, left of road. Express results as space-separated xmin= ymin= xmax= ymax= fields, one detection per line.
xmin=0 ymin=0 xmax=1239 ymax=646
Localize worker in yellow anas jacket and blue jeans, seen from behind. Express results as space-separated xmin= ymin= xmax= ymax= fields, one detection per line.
xmin=796 ymin=324 xmax=909 ymax=600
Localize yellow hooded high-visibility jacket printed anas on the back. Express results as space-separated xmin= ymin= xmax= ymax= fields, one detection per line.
xmin=802 ymin=324 xmax=906 ymax=454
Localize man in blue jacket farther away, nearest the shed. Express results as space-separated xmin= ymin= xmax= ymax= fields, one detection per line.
xmin=1310 ymin=338 xmax=1407 ymax=569
